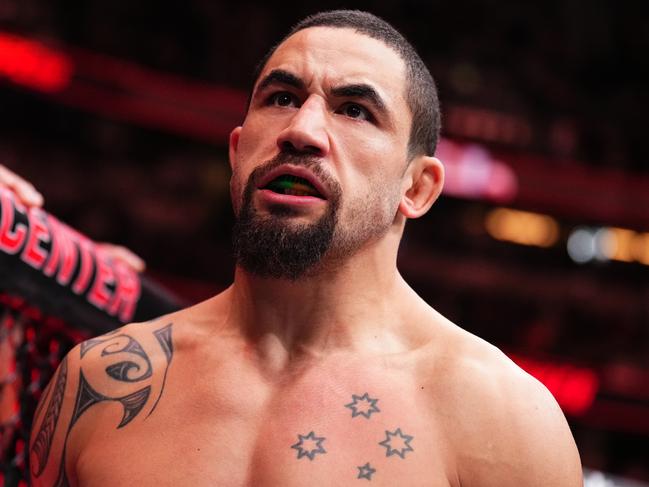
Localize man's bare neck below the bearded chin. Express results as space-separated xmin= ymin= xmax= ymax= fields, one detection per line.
xmin=223 ymin=236 xmax=414 ymax=370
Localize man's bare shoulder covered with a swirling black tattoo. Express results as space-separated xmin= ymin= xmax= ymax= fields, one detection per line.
xmin=29 ymin=317 xmax=174 ymax=486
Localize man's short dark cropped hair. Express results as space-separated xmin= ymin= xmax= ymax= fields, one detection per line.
xmin=248 ymin=10 xmax=441 ymax=158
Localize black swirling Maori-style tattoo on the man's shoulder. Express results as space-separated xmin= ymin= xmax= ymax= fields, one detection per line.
xmin=29 ymin=323 xmax=174 ymax=487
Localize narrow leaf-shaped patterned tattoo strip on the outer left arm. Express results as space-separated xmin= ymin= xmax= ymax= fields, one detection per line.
xmin=32 ymin=358 xmax=68 ymax=477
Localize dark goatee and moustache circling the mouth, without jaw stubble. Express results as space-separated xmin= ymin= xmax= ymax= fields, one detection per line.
xmin=233 ymin=152 xmax=342 ymax=280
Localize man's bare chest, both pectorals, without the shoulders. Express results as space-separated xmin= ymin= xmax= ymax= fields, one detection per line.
xmin=72 ymin=352 xmax=451 ymax=487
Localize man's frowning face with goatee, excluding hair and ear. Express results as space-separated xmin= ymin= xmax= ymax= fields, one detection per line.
xmin=230 ymin=27 xmax=411 ymax=279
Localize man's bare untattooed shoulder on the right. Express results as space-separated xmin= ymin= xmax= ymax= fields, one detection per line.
xmin=420 ymin=312 xmax=583 ymax=487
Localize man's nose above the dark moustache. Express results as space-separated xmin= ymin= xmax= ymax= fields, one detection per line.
xmin=277 ymin=95 xmax=329 ymax=157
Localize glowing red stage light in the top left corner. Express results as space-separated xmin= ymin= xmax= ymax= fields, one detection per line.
xmin=0 ymin=33 xmax=73 ymax=93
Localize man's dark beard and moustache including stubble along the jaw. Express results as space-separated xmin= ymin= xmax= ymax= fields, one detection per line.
xmin=232 ymin=152 xmax=399 ymax=281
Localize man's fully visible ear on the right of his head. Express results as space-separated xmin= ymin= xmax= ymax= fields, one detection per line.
xmin=399 ymin=156 xmax=444 ymax=218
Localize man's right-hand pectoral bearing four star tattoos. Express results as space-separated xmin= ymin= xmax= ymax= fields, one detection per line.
xmin=246 ymin=384 xmax=449 ymax=486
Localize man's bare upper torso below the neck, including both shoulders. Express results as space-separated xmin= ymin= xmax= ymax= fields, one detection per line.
xmin=30 ymin=317 xmax=581 ymax=487
